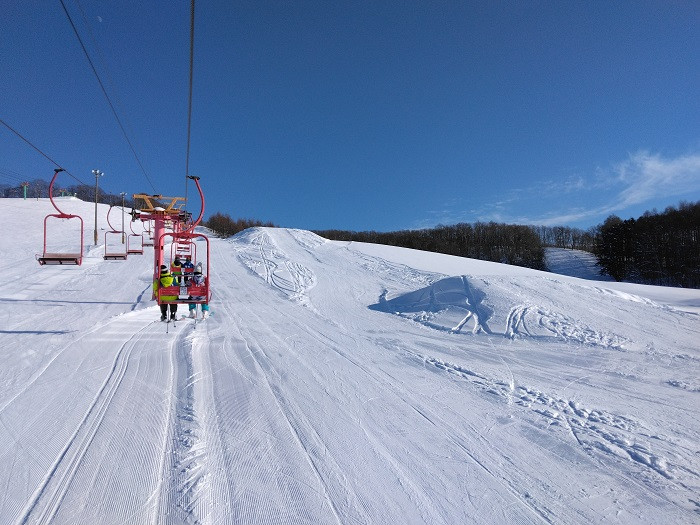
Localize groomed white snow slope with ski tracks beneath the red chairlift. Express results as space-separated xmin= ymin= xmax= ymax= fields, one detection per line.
xmin=0 ymin=199 xmax=700 ymax=524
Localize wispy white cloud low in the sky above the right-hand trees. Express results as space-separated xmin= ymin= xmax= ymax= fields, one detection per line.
xmin=418 ymin=151 xmax=700 ymax=227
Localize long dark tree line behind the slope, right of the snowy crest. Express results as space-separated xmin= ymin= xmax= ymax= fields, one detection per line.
xmin=315 ymin=202 xmax=700 ymax=288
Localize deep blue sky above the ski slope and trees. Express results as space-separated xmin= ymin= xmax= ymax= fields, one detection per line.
xmin=0 ymin=0 xmax=700 ymax=231
